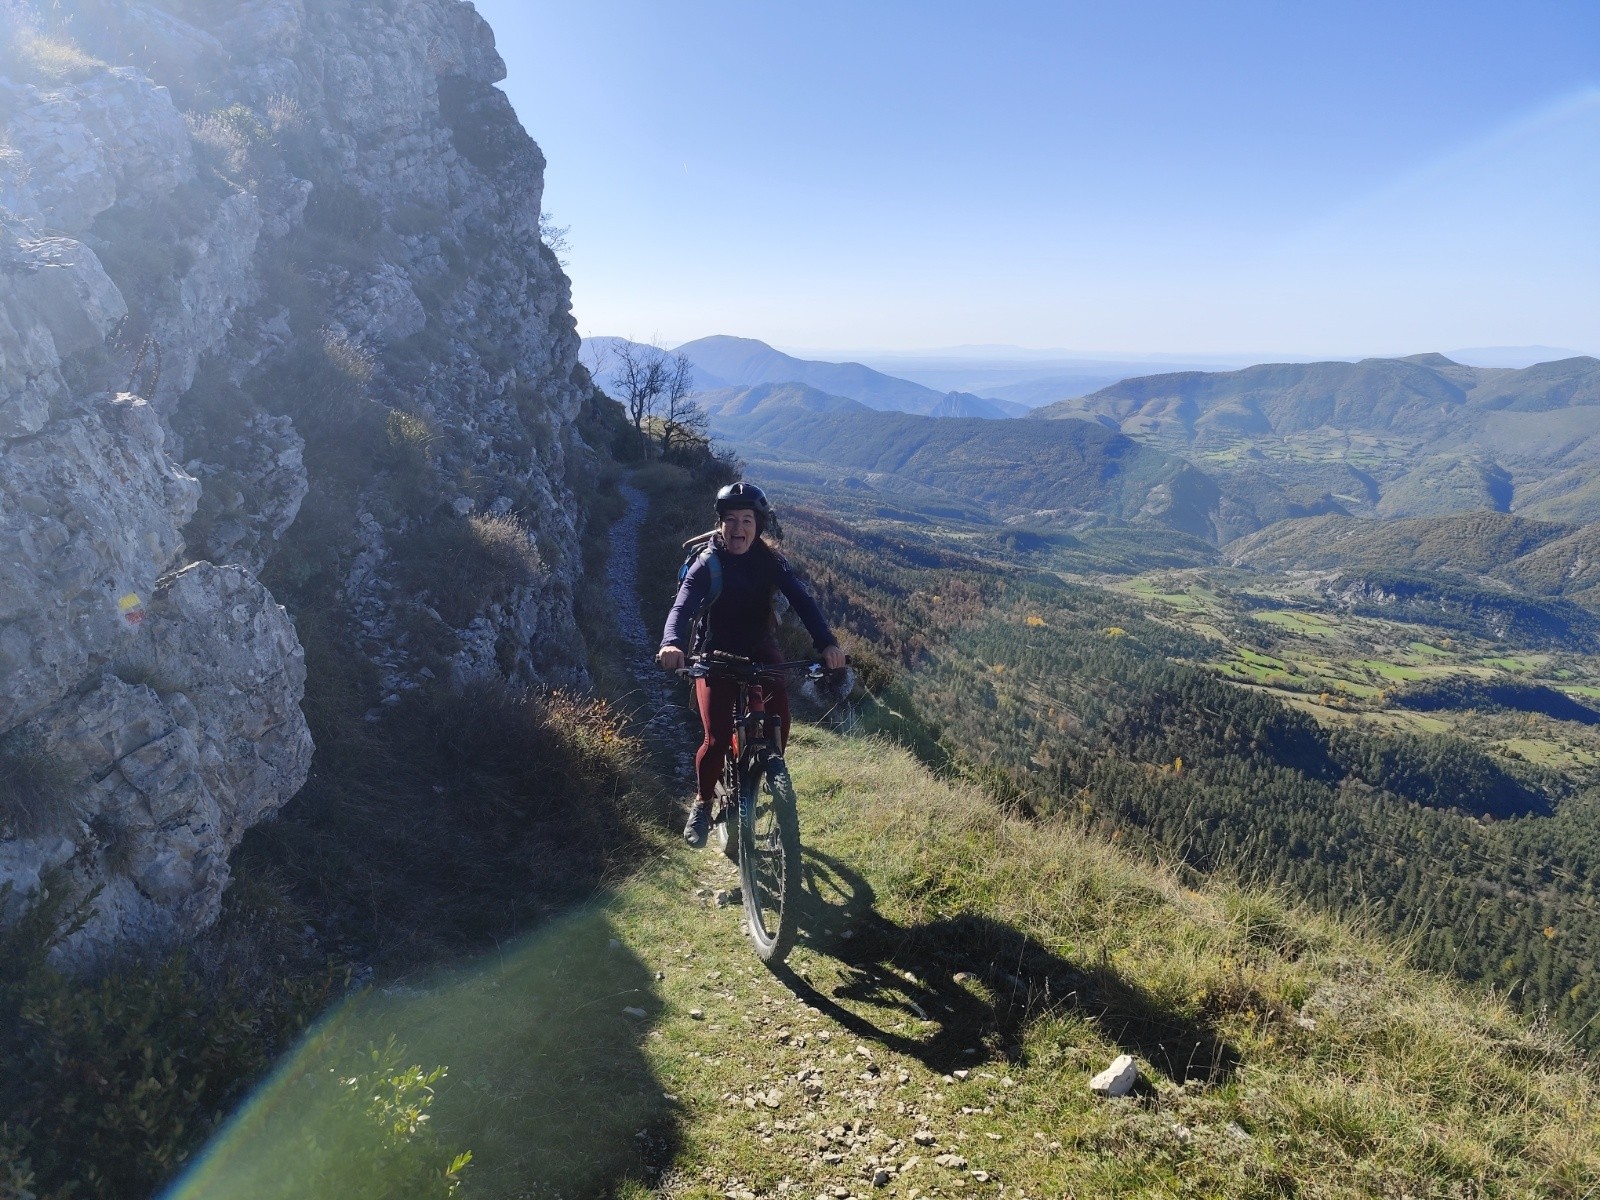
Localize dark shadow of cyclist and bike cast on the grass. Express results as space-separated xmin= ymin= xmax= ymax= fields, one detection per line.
xmin=773 ymin=848 xmax=1240 ymax=1085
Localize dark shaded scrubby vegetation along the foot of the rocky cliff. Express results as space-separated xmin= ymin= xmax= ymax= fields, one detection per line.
xmin=0 ymin=633 xmax=658 ymax=1200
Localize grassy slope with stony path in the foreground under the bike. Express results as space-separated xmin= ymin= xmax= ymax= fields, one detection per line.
xmin=181 ymin=730 xmax=1600 ymax=1200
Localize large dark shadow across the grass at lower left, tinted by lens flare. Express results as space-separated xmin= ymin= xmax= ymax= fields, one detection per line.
xmin=165 ymin=909 xmax=682 ymax=1200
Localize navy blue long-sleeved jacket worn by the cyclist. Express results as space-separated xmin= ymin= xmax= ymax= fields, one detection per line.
xmin=661 ymin=538 xmax=835 ymax=661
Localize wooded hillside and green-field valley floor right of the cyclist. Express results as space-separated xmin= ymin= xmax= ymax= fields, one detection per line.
xmin=787 ymin=510 xmax=1600 ymax=1045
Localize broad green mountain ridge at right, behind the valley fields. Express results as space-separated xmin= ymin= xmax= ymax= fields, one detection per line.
xmin=1034 ymin=354 xmax=1600 ymax=522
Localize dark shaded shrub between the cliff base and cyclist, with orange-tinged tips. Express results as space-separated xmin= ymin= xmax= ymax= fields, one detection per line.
xmin=234 ymin=678 xmax=654 ymax=973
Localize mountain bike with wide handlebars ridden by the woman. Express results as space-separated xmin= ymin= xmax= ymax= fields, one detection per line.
xmin=682 ymin=651 xmax=827 ymax=963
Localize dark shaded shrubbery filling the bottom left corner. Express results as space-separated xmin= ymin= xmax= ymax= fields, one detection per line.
xmin=0 ymin=878 xmax=344 ymax=1200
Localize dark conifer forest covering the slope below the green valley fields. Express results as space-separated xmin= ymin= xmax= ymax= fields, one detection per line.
xmin=784 ymin=507 xmax=1600 ymax=1051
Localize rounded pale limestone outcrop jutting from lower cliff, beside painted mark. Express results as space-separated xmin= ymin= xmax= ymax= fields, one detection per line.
xmin=13 ymin=563 xmax=312 ymax=958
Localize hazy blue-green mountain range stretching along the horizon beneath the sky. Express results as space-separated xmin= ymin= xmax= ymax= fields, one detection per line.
xmin=587 ymin=336 xmax=1600 ymax=546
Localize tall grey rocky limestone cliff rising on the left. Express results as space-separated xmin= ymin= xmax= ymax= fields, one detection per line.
xmin=0 ymin=0 xmax=592 ymax=954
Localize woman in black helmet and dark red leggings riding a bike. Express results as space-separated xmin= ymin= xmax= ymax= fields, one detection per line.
xmin=656 ymin=482 xmax=845 ymax=848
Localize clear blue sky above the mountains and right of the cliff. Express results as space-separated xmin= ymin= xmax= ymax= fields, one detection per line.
xmin=477 ymin=0 xmax=1600 ymax=354
